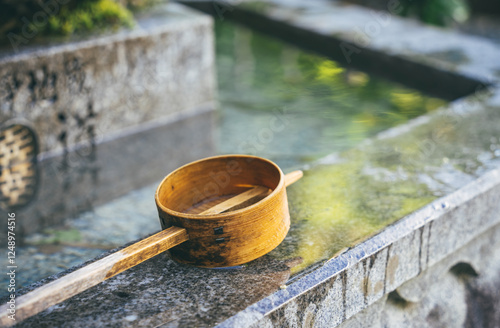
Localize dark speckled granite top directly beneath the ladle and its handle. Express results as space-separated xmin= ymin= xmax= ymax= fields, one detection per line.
xmin=9 ymin=254 xmax=296 ymax=327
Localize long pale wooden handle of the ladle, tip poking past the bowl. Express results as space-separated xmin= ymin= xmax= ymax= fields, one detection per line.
xmin=0 ymin=171 xmax=302 ymax=327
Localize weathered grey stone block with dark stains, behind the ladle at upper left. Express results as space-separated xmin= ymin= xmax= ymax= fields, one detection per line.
xmin=0 ymin=4 xmax=215 ymax=152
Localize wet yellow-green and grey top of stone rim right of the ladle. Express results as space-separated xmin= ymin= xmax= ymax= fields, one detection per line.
xmin=271 ymin=98 xmax=500 ymax=273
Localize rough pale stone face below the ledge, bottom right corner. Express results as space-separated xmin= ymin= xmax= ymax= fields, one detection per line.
xmin=339 ymin=220 xmax=500 ymax=327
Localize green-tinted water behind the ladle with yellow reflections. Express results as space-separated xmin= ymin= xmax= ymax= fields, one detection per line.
xmin=215 ymin=22 xmax=444 ymax=169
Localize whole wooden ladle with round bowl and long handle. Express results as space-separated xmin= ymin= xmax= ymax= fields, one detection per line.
xmin=0 ymin=155 xmax=302 ymax=326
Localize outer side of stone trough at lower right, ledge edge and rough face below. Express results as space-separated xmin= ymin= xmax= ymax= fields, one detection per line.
xmin=227 ymin=165 xmax=500 ymax=327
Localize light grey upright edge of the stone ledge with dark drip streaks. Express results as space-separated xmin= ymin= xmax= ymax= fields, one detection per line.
xmin=219 ymin=155 xmax=500 ymax=327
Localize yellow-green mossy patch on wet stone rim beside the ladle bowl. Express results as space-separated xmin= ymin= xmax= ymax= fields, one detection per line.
xmin=289 ymin=150 xmax=436 ymax=272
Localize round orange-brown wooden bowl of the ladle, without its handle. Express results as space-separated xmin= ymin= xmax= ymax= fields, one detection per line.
xmin=155 ymin=155 xmax=290 ymax=267
